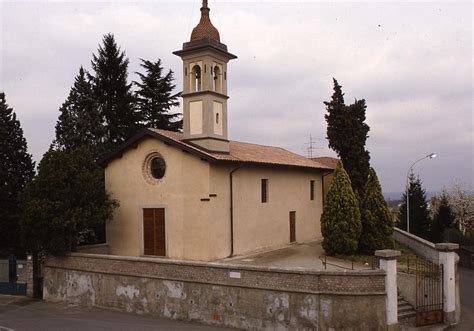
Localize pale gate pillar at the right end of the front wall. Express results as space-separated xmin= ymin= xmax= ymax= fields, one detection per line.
xmin=375 ymin=249 xmax=401 ymax=327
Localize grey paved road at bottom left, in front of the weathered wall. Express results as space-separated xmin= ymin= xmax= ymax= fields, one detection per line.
xmin=0 ymin=295 xmax=230 ymax=331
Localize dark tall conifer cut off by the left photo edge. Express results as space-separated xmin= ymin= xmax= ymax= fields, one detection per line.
xmin=0 ymin=92 xmax=34 ymax=255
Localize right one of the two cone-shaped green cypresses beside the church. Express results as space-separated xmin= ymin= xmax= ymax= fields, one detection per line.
xmin=359 ymin=168 xmax=393 ymax=254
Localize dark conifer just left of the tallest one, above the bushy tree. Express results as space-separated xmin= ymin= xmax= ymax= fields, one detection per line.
xmin=54 ymin=67 xmax=105 ymax=156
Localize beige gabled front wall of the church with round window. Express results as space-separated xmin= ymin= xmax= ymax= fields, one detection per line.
xmin=105 ymin=139 xmax=212 ymax=260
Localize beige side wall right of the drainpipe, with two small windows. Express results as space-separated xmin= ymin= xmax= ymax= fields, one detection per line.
xmin=234 ymin=167 xmax=322 ymax=255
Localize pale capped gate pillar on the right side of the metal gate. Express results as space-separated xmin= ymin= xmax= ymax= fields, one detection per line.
xmin=435 ymin=243 xmax=459 ymax=325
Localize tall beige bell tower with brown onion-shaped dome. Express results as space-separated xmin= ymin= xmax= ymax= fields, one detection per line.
xmin=173 ymin=0 xmax=237 ymax=153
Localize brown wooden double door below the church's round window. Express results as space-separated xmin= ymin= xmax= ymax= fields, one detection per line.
xmin=143 ymin=208 xmax=166 ymax=256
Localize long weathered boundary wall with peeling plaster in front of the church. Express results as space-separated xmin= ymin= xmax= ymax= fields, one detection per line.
xmin=43 ymin=253 xmax=386 ymax=330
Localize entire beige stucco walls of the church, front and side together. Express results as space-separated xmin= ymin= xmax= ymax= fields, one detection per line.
xmin=105 ymin=138 xmax=322 ymax=261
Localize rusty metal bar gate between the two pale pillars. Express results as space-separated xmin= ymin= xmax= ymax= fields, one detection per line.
xmin=415 ymin=258 xmax=443 ymax=326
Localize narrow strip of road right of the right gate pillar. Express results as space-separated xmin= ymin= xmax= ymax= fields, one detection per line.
xmin=451 ymin=267 xmax=474 ymax=331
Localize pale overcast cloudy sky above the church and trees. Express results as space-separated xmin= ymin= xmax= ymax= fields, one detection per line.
xmin=0 ymin=0 xmax=474 ymax=192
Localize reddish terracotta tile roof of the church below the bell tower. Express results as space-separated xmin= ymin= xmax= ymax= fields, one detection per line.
xmin=148 ymin=129 xmax=333 ymax=169
